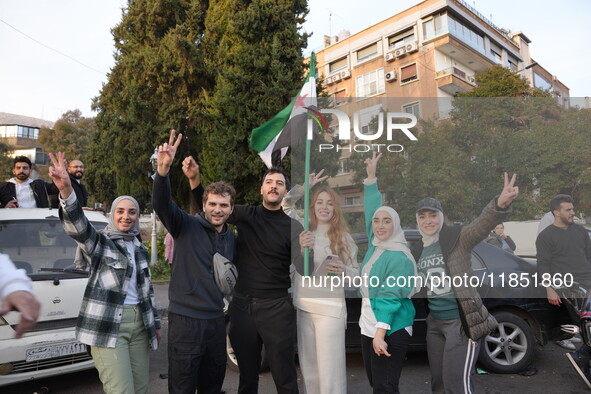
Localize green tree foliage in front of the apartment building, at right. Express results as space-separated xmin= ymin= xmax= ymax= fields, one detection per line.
xmin=346 ymin=66 xmax=591 ymax=225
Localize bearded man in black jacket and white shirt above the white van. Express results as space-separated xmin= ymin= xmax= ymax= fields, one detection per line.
xmin=0 ymin=156 xmax=59 ymax=208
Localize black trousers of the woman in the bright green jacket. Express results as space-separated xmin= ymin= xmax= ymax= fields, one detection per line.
xmin=361 ymin=328 xmax=410 ymax=393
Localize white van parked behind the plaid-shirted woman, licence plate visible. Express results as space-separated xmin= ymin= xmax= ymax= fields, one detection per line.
xmin=0 ymin=208 xmax=107 ymax=391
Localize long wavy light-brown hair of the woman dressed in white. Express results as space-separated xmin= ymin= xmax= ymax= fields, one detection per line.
xmin=309 ymin=186 xmax=353 ymax=264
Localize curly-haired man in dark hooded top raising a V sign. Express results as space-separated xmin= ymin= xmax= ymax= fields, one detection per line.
xmin=152 ymin=130 xmax=236 ymax=394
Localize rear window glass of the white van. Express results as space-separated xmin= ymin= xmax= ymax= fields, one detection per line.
xmin=0 ymin=219 xmax=105 ymax=279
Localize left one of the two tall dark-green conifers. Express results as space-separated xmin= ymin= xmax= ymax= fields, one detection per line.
xmin=88 ymin=0 xmax=211 ymax=206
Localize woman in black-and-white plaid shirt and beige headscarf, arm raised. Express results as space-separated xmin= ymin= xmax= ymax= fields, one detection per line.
xmin=49 ymin=152 xmax=160 ymax=394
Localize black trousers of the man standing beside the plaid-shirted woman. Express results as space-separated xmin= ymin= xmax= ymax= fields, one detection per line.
xmin=168 ymin=312 xmax=226 ymax=394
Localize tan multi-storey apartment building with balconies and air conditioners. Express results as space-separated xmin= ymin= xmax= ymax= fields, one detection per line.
xmin=316 ymin=0 xmax=569 ymax=213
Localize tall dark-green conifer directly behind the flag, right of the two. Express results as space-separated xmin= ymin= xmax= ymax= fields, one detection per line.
xmin=201 ymin=0 xmax=307 ymax=203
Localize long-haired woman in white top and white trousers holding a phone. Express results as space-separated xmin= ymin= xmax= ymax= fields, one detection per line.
xmin=293 ymin=187 xmax=359 ymax=394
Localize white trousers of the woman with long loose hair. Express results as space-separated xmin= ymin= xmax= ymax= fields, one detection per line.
xmin=298 ymin=309 xmax=347 ymax=394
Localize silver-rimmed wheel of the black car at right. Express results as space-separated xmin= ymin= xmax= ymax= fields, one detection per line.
xmin=478 ymin=312 xmax=535 ymax=373
